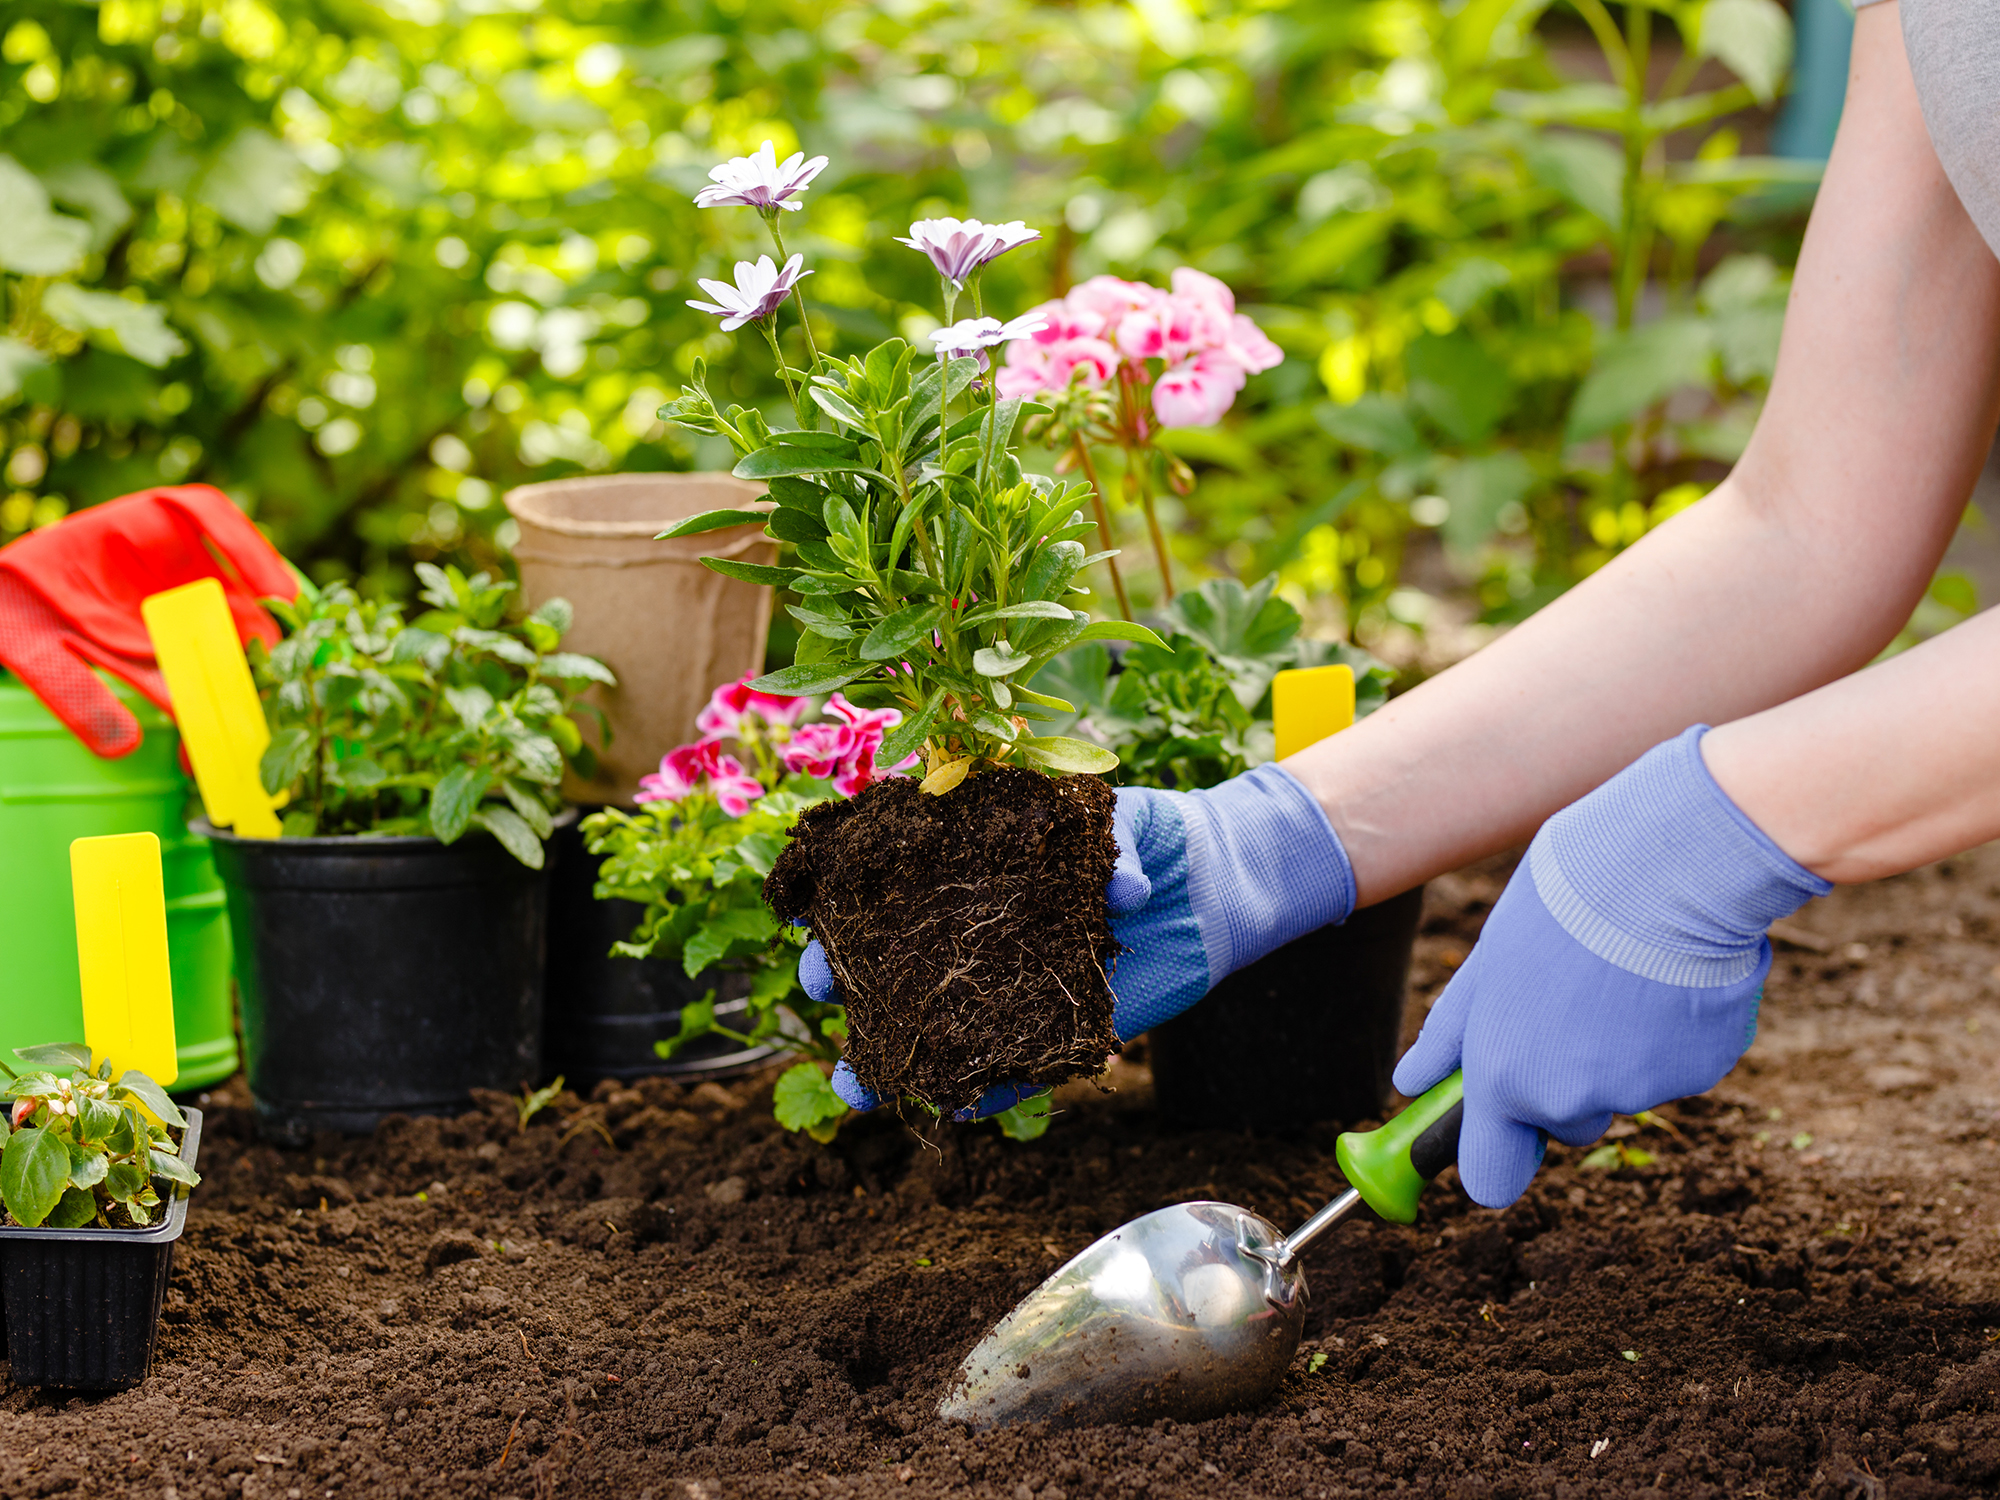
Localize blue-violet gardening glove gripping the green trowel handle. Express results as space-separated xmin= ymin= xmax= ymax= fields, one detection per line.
xmin=1396 ymin=724 xmax=1832 ymax=1208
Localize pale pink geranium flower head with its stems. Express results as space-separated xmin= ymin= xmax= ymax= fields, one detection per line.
xmin=996 ymin=266 xmax=1284 ymax=618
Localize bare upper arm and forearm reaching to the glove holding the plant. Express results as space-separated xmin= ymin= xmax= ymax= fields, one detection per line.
xmin=1286 ymin=4 xmax=2000 ymax=904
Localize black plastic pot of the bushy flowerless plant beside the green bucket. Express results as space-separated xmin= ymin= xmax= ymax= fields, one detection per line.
xmin=196 ymin=812 xmax=576 ymax=1144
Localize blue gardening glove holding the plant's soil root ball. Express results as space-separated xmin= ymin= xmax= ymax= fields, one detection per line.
xmin=816 ymin=764 xmax=1354 ymax=1118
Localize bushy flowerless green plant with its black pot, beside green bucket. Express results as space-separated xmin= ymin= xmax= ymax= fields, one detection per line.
xmin=198 ymin=564 xmax=610 ymax=1142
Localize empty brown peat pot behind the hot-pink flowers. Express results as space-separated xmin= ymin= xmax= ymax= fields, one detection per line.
xmin=506 ymin=474 xmax=778 ymax=804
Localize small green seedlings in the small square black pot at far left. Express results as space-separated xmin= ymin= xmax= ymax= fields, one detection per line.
xmin=0 ymin=1042 xmax=200 ymax=1230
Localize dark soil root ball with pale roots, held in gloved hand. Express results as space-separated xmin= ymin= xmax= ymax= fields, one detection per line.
xmin=764 ymin=768 xmax=1118 ymax=1110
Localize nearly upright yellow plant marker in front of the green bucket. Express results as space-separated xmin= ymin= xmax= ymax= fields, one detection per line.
xmin=70 ymin=834 xmax=180 ymax=1084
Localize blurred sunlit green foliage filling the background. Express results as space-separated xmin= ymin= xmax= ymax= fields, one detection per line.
xmin=0 ymin=0 xmax=1812 ymax=638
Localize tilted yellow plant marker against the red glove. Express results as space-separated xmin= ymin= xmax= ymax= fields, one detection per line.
xmin=140 ymin=578 xmax=278 ymax=838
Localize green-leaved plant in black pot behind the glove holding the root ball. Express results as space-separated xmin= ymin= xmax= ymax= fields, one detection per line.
xmin=1036 ymin=578 xmax=1424 ymax=1130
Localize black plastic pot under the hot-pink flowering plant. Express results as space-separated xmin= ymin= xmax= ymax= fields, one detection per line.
xmin=542 ymin=826 xmax=776 ymax=1084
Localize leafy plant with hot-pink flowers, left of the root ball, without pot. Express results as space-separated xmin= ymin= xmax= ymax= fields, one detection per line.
xmin=584 ymin=678 xmax=914 ymax=1140
